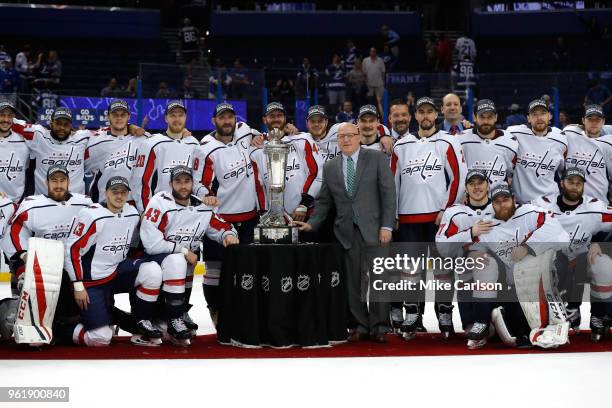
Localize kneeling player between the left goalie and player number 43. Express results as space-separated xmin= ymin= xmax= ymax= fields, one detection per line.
xmin=61 ymin=176 xmax=162 ymax=346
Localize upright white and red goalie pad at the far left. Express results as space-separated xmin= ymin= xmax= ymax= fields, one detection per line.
xmin=14 ymin=238 xmax=64 ymax=344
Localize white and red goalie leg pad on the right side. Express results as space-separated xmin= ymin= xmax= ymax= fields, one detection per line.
xmin=514 ymin=249 xmax=569 ymax=348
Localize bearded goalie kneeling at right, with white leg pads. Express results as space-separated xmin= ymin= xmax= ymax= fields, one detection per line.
xmin=470 ymin=184 xmax=569 ymax=348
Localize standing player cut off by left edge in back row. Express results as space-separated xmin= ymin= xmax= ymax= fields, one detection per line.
xmin=0 ymin=101 xmax=30 ymax=204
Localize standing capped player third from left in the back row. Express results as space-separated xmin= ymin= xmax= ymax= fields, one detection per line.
xmin=85 ymin=99 xmax=146 ymax=202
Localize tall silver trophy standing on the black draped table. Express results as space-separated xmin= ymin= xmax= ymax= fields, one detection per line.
xmin=255 ymin=128 xmax=298 ymax=244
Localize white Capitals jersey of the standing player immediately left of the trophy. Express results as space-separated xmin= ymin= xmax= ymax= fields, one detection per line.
xmin=193 ymin=122 xmax=256 ymax=223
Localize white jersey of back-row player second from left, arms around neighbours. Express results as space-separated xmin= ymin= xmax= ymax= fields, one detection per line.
xmin=13 ymin=119 xmax=92 ymax=194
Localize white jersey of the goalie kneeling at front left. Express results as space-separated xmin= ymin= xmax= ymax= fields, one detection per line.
xmin=2 ymin=194 xmax=92 ymax=258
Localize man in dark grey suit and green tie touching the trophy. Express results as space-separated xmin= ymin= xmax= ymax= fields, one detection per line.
xmin=295 ymin=123 xmax=397 ymax=343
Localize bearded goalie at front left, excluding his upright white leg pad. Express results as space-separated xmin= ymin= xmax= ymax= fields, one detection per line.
xmin=2 ymin=165 xmax=92 ymax=302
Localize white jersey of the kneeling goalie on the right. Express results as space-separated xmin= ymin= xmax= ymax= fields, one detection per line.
xmin=471 ymin=204 xmax=569 ymax=271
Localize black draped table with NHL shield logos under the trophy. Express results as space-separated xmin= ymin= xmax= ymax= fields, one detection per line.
xmin=217 ymin=244 xmax=347 ymax=347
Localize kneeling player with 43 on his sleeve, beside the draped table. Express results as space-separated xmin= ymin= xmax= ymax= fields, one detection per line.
xmin=140 ymin=165 xmax=238 ymax=345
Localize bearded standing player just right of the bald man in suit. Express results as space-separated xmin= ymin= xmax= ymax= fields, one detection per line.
xmin=457 ymin=99 xmax=518 ymax=188
